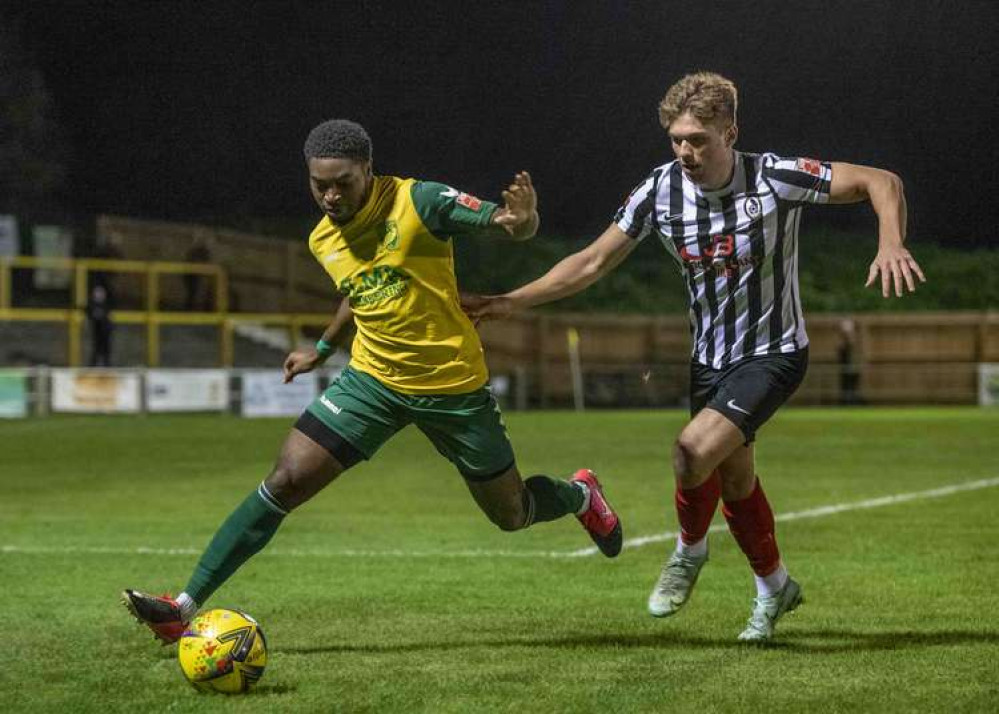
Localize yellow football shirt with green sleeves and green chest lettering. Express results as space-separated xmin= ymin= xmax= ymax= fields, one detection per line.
xmin=309 ymin=176 xmax=496 ymax=394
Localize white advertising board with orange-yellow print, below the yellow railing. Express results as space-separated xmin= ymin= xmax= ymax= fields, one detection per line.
xmin=52 ymin=369 xmax=142 ymax=414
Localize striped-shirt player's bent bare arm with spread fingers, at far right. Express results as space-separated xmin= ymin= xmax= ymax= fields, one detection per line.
xmin=829 ymin=163 xmax=926 ymax=297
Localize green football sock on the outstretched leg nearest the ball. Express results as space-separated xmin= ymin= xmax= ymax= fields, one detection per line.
xmin=184 ymin=484 xmax=288 ymax=605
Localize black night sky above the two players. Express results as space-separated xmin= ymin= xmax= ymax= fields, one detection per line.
xmin=8 ymin=0 xmax=999 ymax=247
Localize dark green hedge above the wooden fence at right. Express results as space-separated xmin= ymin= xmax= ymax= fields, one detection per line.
xmin=455 ymin=229 xmax=999 ymax=314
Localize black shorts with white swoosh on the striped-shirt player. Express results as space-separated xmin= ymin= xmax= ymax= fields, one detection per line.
xmin=690 ymin=347 xmax=808 ymax=444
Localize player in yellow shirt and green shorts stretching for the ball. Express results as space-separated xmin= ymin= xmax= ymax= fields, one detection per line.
xmin=123 ymin=119 xmax=622 ymax=643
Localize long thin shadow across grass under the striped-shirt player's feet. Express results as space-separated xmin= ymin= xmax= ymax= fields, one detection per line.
xmin=271 ymin=629 xmax=999 ymax=655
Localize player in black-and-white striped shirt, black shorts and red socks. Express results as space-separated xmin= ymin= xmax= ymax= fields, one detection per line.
xmin=465 ymin=72 xmax=924 ymax=641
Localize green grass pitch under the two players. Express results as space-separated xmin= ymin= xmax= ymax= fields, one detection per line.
xmin=0 ymin=408 xmax=999 ymax=714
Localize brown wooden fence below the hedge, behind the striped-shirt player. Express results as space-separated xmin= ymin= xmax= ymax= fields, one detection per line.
xmin=480 ymin=312 xmax=999 ymax=407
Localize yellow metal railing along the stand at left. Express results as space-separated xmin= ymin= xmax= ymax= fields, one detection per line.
xmin=0 ymin=256 xmax=331 ymax=367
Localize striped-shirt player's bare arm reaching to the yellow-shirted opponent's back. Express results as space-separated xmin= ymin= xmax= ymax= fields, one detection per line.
xmin=462 ymin=223 xmax=638 ymax=322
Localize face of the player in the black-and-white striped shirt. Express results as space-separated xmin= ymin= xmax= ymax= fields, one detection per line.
xmin=669 ymin=112 xmax=739 ymax=189
